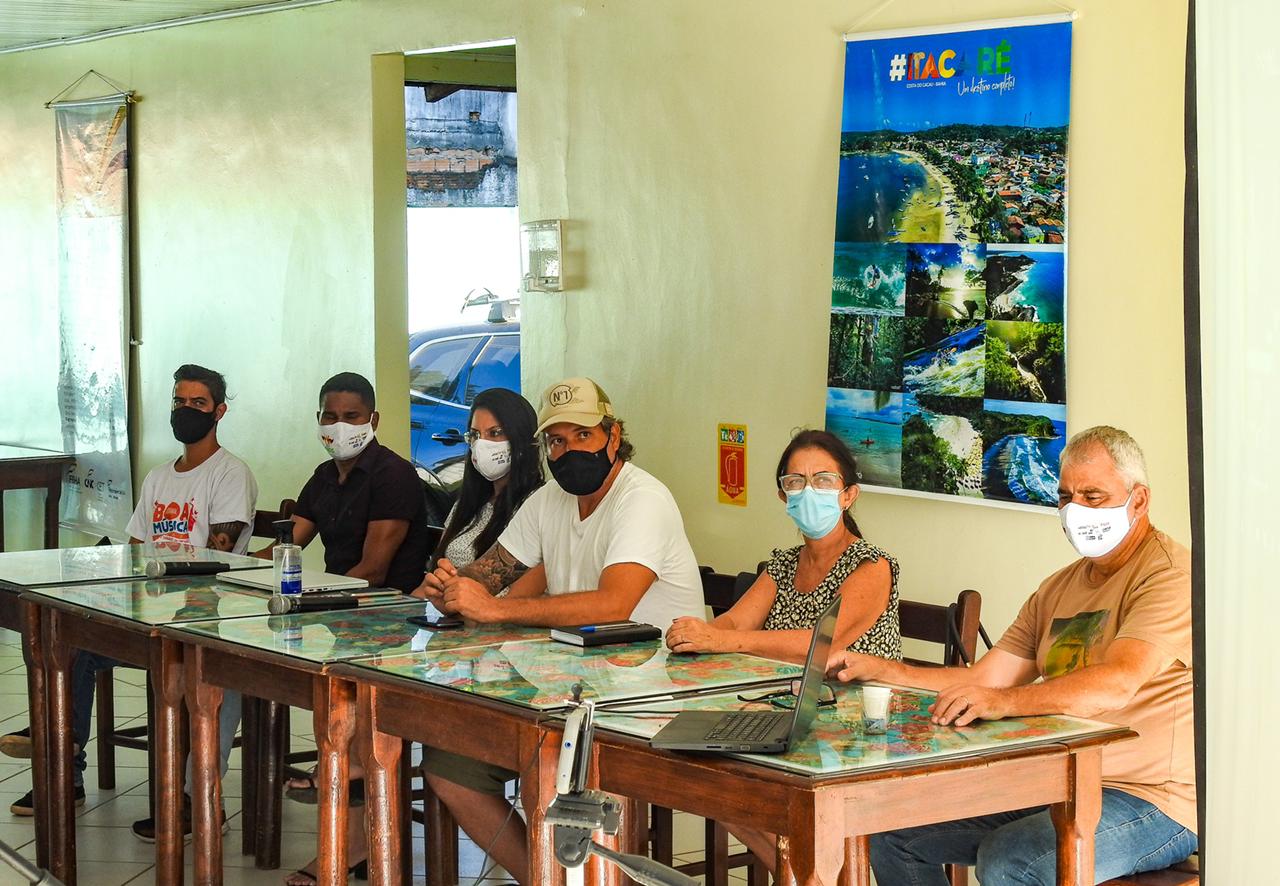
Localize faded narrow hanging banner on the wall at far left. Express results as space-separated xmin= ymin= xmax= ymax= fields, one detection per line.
xmin=54 ymin=96 xmax=133 ymax=540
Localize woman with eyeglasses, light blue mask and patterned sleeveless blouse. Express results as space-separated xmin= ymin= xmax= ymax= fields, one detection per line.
xmin=667 ymin=430 xmax=902 ymax=662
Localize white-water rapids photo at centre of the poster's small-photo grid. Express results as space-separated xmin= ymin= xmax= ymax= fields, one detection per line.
xmin=902 ymin=318 xmax=986 ymax=397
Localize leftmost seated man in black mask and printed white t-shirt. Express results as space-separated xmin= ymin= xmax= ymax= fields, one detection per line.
xmin=0 ymin=364 xmax=257 ymax=842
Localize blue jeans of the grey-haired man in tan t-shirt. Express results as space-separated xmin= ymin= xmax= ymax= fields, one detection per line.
xmin=870 ymin=787 xmax=1198 ymax=886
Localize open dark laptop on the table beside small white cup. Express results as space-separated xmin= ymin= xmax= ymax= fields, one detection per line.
xmin=649 ymin=595 xmax=840 ymax=754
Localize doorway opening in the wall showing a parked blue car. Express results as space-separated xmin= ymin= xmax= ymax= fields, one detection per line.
xmin=404 ymin=42 xmax=521 ymax=501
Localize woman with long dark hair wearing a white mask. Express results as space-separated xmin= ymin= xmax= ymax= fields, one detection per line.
xmin=428 ymin=388 xmax=543 ymax=571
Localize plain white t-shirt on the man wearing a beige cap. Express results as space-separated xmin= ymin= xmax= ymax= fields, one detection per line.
xmin=498 ymin=462 xmax=705 ymax=631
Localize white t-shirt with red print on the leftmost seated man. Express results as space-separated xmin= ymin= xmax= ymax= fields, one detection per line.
xmin=128 ymin=449 xmax=257 ymax=553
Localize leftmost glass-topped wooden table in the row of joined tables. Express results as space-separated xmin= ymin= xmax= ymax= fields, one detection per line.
xmin=20 ymin=568 xmax=275 ymax=886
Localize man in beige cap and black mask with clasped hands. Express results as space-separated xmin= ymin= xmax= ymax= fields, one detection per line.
xmin=417 ymin=378 xmax=705 ymax=883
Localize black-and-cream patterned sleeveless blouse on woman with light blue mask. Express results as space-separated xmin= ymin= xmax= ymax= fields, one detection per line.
xmin=764 ymin=539 xmax=902 ymax=659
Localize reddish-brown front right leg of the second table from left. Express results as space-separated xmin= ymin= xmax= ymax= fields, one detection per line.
xmin=312 ymin=675 xmax=358 ymax=886
